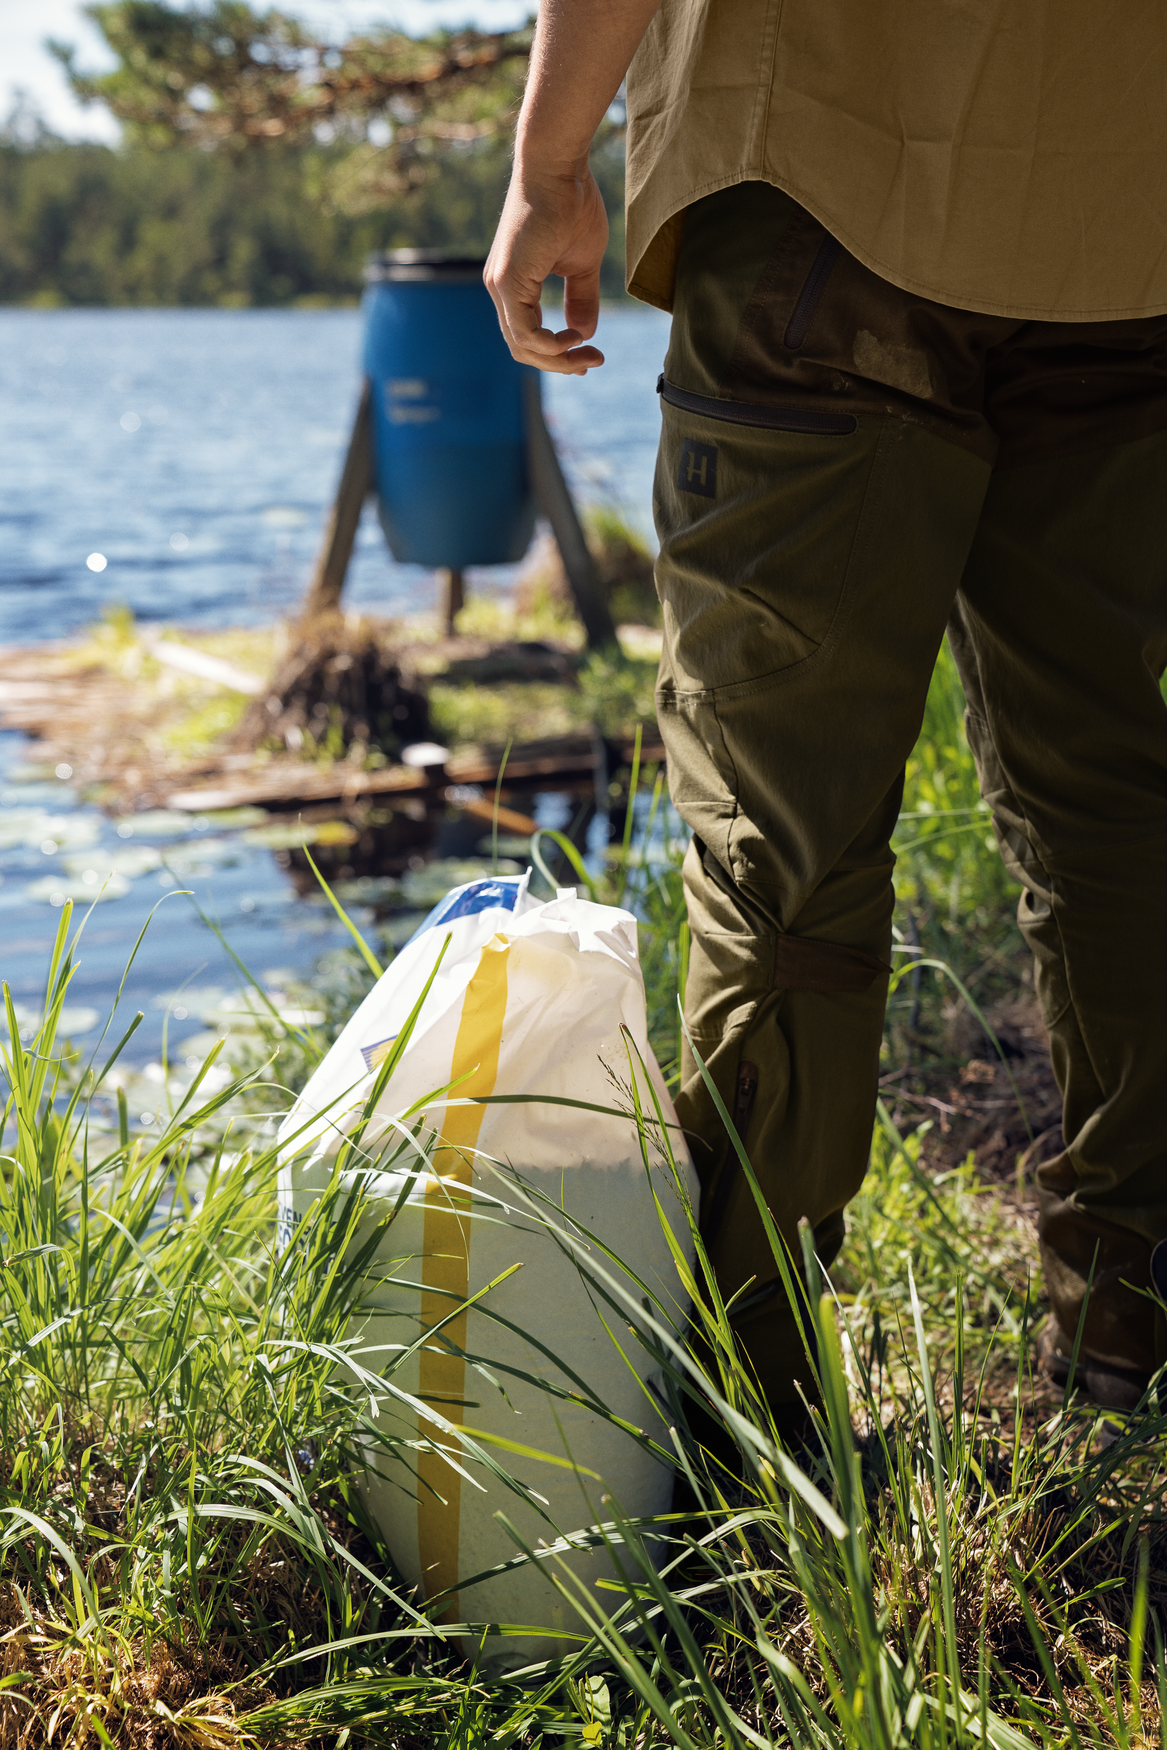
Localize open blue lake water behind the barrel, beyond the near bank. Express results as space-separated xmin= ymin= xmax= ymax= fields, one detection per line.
xmin=0 ymin=308 xmax=668 ymax=644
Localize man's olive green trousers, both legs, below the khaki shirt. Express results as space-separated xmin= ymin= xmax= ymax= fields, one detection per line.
xmin=654 ymin=184 xmax=1167 ymax=1405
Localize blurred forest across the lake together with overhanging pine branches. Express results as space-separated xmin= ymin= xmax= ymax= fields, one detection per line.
xmin=0 ymin=0 xmax=625 ymax=308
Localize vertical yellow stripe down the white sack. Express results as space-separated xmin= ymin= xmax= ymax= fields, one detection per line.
xmin=418 ymin=936 xmax=511 ymax=1622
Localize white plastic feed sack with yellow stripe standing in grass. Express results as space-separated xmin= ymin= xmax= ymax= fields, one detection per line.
xmin=280 ymin=877 xmax=696 ymax=1668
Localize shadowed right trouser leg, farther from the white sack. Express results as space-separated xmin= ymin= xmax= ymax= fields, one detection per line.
xmin=950 ymin=434 xmax=1167 ymax=1372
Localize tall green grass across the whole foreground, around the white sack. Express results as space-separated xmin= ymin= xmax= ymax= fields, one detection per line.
xmin=0 ymin=707 xmax=1167 ymax=1750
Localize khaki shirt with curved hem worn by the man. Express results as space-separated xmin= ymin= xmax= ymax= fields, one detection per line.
xmin=626 ymin=0 xmax=1167 ymax=322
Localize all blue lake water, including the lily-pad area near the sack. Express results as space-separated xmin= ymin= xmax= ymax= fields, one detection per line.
xmin=0 ymin=310 xmax=668 ymax=1078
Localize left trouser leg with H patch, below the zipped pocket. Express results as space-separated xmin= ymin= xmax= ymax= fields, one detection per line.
xmin=656 ymin=408 xmax=989 ymax=1405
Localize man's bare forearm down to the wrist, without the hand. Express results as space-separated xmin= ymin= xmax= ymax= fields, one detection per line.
xmin=514 ymin=0 xmax=660 ymax=175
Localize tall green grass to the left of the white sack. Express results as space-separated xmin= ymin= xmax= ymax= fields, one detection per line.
xmin=0 ymin=907 xmax=442 ymax=1745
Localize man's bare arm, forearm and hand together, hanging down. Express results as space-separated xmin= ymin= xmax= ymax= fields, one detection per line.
xmin=483 ymin=0 xmax=660 ymax=376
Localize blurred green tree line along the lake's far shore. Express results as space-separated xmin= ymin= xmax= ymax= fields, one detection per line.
xmin=0 ymin=137 xmax=623 ymax=306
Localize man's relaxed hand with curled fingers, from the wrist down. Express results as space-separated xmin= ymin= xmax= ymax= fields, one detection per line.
xmin=483 ymin=165 xmax=607 ymax=376
